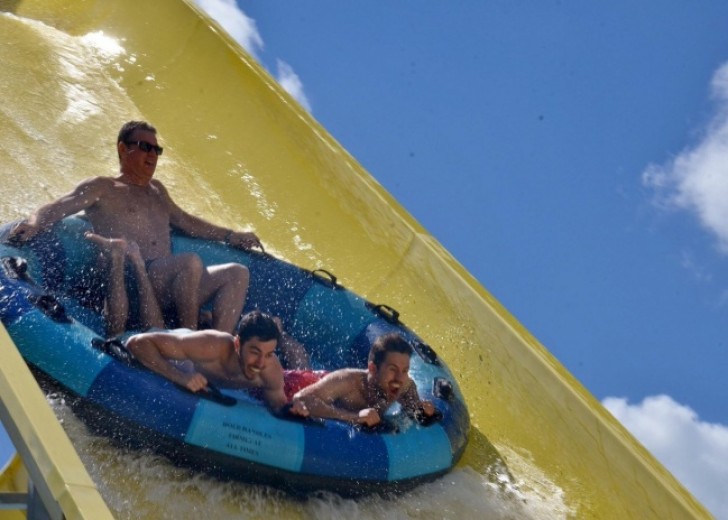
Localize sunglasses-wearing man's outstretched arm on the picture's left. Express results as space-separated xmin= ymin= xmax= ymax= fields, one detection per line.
xmin=8 ymin=177 xmax=113 ymax=242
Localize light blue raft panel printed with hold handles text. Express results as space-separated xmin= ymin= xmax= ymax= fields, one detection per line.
xmin=185 ymin=400 xmax=304 ymax=471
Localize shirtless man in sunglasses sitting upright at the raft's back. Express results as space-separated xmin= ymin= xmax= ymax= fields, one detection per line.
xmin=9 ymin=121 xmax=262 ymax=332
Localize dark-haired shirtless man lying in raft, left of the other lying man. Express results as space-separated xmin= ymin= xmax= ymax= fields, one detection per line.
xmin=126 ymin=311 xmax=308 ymax=417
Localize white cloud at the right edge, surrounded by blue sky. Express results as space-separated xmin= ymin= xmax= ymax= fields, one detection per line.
xmin=642 ymin=63 xmax=728 ymax=254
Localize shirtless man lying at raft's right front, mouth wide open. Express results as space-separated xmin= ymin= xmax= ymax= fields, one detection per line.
xmin=292 ymin=333 xmax=435 ymax=426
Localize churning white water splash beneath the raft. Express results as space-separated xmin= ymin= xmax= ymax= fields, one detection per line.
xmin=48 ymin=394 xmax=569 ymax=520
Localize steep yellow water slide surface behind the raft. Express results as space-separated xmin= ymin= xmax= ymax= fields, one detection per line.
xmin=0 ymin=0 xmax=710 ymax=520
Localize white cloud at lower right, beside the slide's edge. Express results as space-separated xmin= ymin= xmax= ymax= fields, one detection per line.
xmin=603 ymin=395 xmax=728 ymax=519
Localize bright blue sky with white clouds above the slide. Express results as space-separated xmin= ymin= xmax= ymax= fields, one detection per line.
xmin=0 ymin=0 xmax=728 ymax=519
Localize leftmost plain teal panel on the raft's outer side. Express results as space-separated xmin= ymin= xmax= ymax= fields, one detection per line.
xmin=8 ymin=310 xmax=111 ymax=396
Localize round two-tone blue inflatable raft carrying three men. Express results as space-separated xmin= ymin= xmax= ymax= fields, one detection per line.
xmin=0 ymin=217 xmax=470 ymax=496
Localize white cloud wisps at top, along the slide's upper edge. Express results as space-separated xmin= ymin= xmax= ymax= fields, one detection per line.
xmin=195 ymin=0 xmax=311 ymax=112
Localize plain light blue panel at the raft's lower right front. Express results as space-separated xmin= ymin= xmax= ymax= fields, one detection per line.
xmin=383 ymin=424 xmax=453 ymax=481
